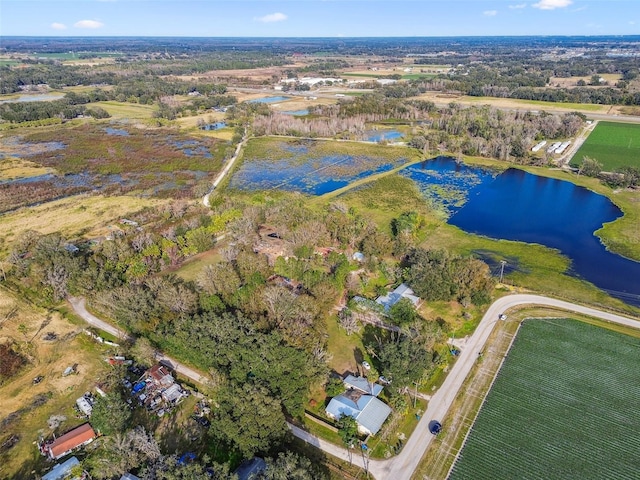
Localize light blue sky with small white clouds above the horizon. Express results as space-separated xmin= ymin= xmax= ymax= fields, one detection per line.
xmin=0 ymin=0 xmax=640 ymax=37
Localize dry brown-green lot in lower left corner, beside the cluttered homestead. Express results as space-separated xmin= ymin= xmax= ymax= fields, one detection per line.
xmin=0 ymin=289 xmax=109 ymax=478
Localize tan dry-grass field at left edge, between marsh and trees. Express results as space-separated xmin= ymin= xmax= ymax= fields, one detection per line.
xmin=0 ymin=195 xmax=169 ymax=253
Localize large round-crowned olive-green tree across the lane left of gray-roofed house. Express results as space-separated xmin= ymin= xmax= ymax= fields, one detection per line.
xmin=210 ymin=383 xmax=289 ymax=458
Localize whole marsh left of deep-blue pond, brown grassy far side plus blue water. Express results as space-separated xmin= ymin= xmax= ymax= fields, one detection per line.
xmin=230 ymin=138 xmax=417 ymax=195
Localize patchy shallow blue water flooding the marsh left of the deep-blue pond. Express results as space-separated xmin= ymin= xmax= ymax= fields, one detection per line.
xmin=230 ymin=150 xmax=407 ymax=195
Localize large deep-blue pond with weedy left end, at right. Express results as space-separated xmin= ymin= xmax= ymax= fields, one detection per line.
xmin=403 ymin=158 xmax=640 ymax=306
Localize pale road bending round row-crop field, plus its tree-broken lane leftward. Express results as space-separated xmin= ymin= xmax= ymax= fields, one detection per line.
xmin=69 ymin=294 xmax=640 ymax=480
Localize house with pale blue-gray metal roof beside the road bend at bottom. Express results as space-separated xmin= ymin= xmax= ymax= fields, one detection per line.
xmin=325 ymin=385 xmax=391 ymax=435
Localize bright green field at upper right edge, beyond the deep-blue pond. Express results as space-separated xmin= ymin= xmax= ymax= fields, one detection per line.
xmin=571 ymin=122 xmax=640 ymax=172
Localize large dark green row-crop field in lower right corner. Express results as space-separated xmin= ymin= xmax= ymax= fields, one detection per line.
xmin=445 ymin=319 xmax=640 ymax=480
